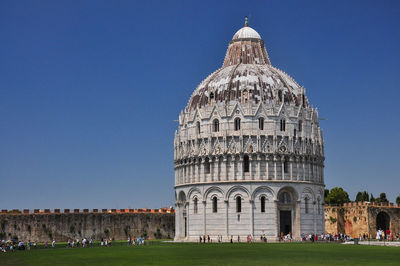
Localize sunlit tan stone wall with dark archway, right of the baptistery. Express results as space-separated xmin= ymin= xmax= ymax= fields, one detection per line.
xmin=325 ymin=202 xmax=400 ymax=238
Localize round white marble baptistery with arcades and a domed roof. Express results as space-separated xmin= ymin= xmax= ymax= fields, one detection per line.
xmin=174 ymin=19 xmax=325 ymax=241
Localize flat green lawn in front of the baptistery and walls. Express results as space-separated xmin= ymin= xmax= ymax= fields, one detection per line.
xmin=0 ymin=242 xmax=400 ymax=265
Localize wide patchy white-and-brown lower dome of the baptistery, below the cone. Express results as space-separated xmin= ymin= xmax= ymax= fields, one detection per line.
xmin=187 ymin=64 xmax=308 ymax=110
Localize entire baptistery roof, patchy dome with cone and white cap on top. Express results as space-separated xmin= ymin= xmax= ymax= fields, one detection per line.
xmin=186 ymin=18 xmax=308 ymax=111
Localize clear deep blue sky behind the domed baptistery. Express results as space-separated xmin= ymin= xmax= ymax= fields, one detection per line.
xmin=0 ymin=1 xmax=400 ymax=209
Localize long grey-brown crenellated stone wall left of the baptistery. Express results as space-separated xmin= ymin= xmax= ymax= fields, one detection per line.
xmin=0 ymin=211 xmax=175 ymax=242
